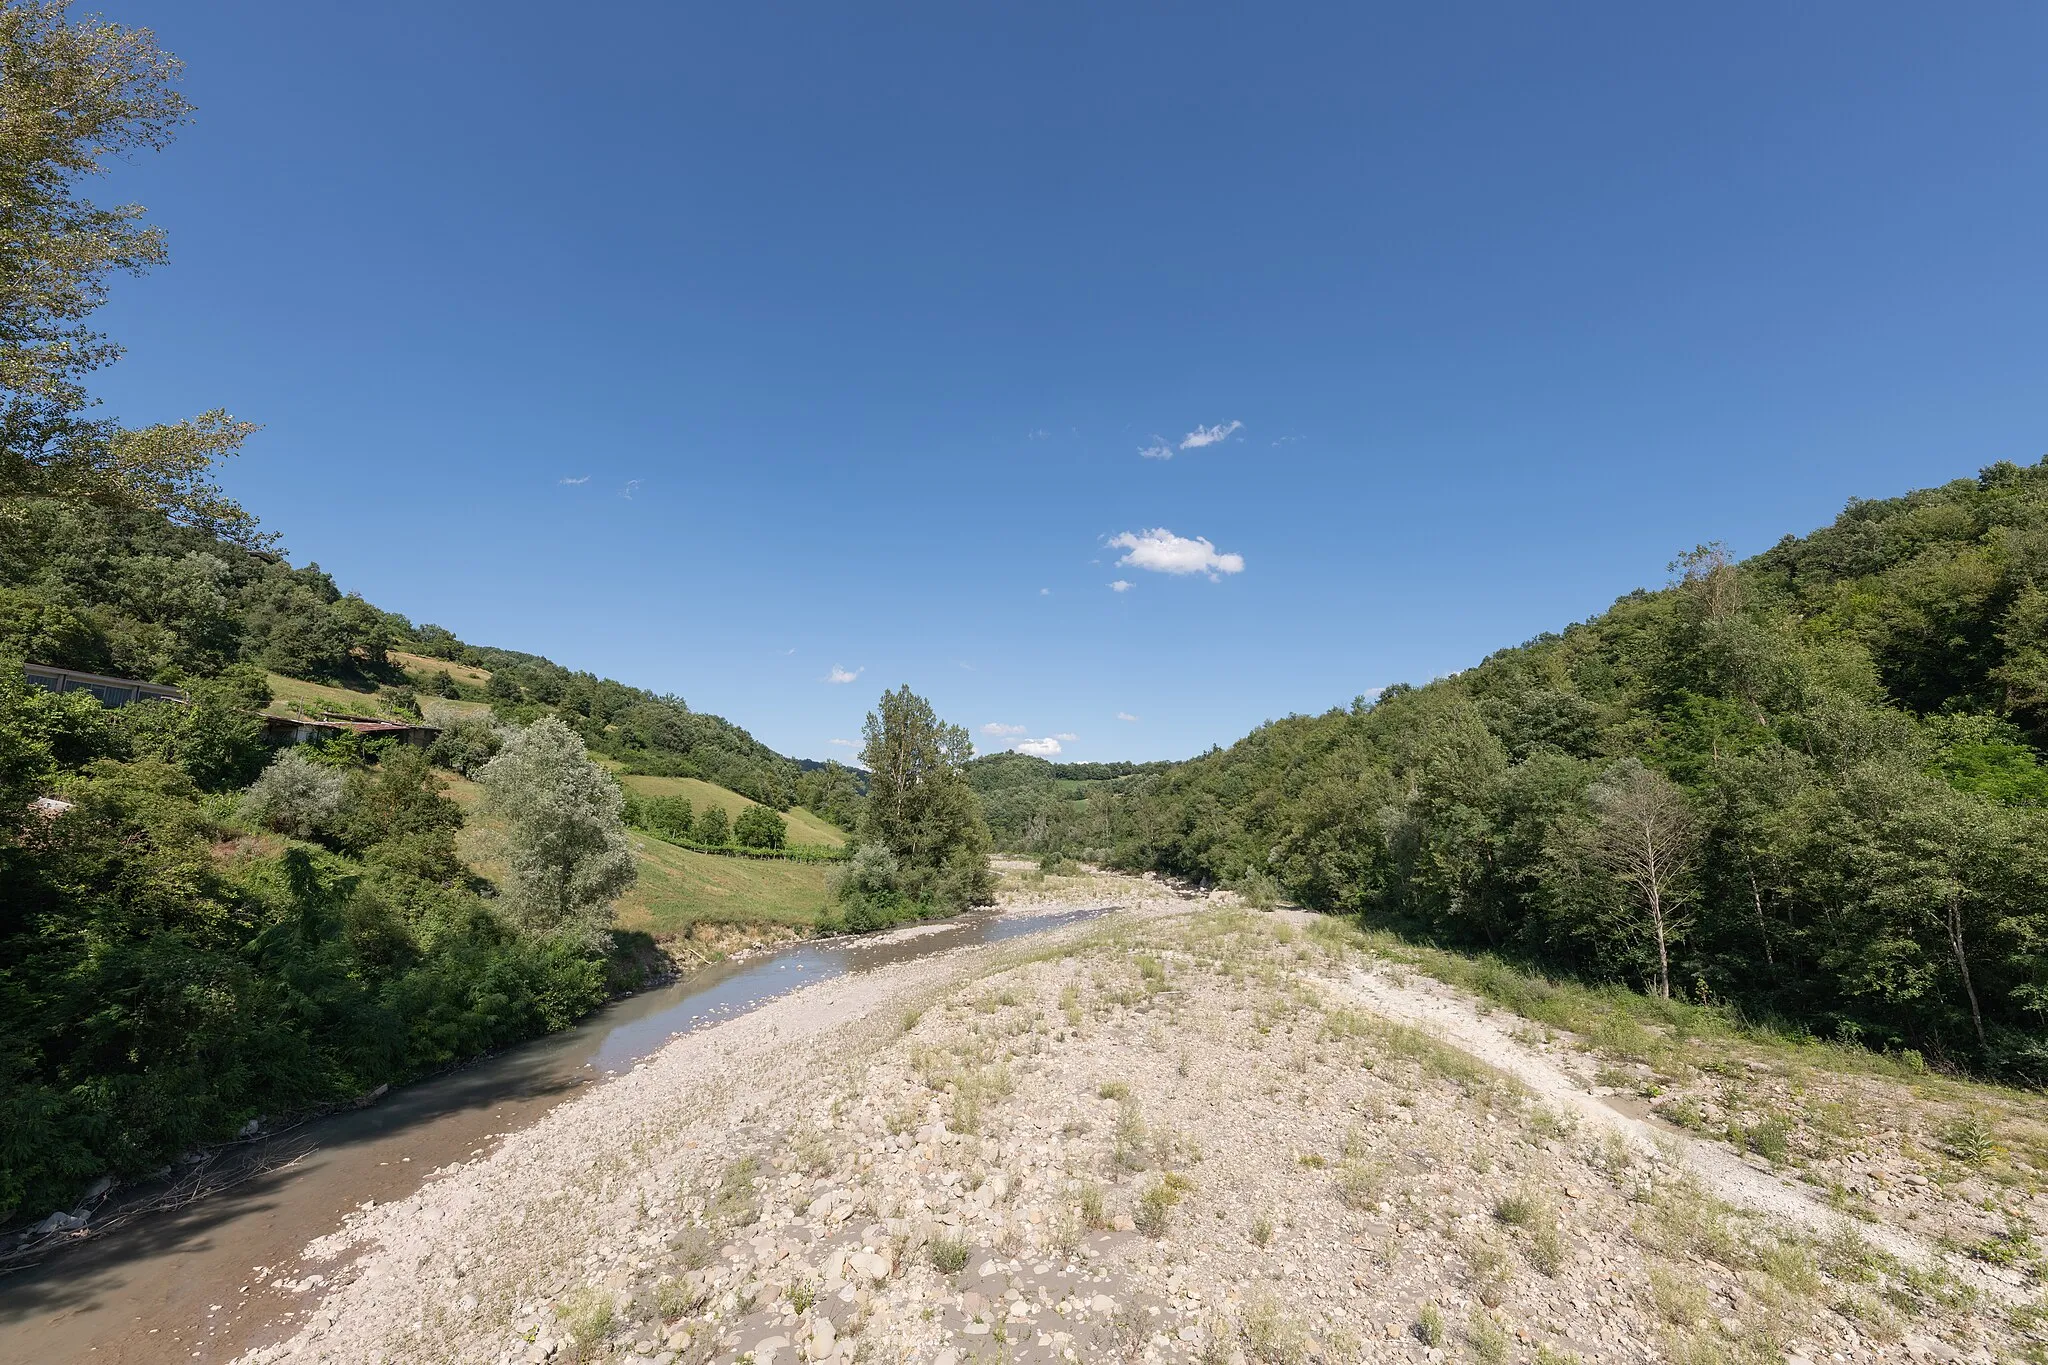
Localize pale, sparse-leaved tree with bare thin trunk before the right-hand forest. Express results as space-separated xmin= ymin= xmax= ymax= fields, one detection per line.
xmin=1587 ymin=759 xmax=1698 ymax=999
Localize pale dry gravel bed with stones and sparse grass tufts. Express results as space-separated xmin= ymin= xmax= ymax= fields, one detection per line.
xmin=246 ymin=874 xmax=2048 ymax=1365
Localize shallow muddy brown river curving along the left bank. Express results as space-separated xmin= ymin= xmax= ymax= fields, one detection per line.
xmin=0 ymin=909 xmax=1104 ymax=1365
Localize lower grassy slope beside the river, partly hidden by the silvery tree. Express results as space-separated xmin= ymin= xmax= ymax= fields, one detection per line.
xmin=442 ymin=774 xmax=829 ymax=939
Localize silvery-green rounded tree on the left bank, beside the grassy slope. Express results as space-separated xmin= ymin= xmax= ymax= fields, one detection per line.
xmin=477 ymin=716 xmax=637 ymax=950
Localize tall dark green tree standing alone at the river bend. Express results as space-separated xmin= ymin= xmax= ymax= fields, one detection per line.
xmin=860 ymin=686 xmax=995 ymax=907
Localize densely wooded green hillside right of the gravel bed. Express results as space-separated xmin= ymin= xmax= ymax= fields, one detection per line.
xmin=1100 ymin=460 xmax=2048 ymax=1078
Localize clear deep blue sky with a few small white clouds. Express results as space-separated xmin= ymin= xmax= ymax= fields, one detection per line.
xmin=98 ymin=0 xmax=2048 ymax=759
